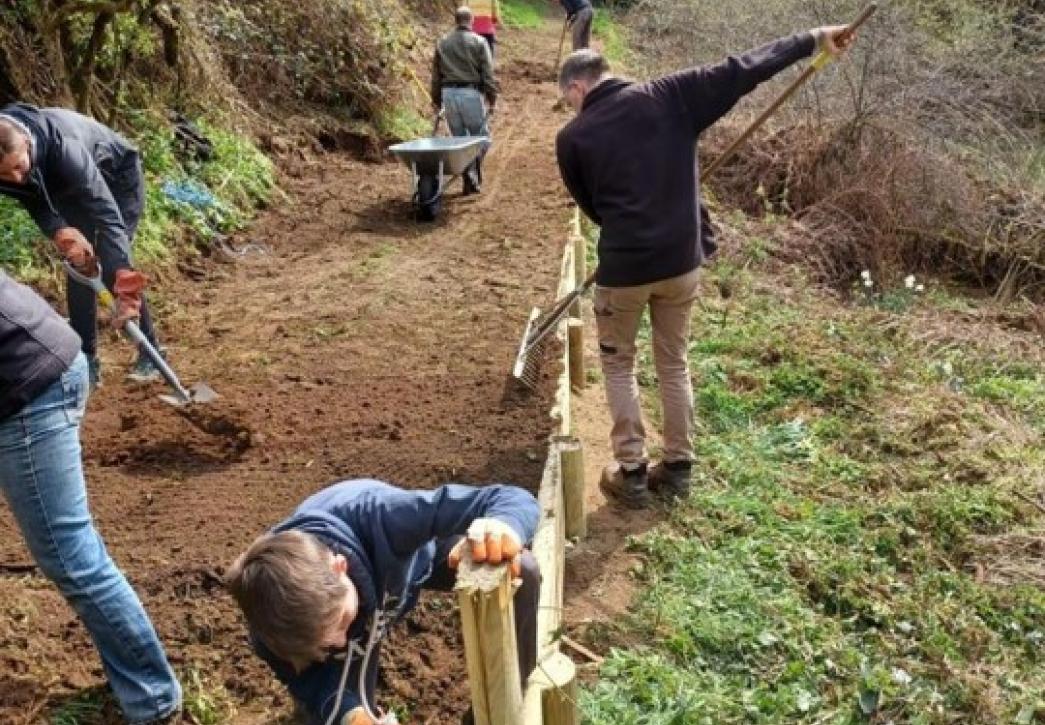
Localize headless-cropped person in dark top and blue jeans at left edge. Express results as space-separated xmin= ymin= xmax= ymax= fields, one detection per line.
xmin=0 ymin=272 xmax=182 ymax=723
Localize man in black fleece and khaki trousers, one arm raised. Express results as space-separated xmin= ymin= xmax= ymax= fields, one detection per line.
xmin=556 ymin=26 xmax=852 ymax=508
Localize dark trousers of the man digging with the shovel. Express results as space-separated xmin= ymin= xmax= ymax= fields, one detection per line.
xmin=66 ymin=156 xmax=157 ymax=357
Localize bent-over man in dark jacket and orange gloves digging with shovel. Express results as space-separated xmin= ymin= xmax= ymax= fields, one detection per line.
xmin=0 ymin=103 xmax=160 ymax=387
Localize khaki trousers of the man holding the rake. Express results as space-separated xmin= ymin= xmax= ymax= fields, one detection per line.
xmin=595 ymin=270 xmax=697 ymax=464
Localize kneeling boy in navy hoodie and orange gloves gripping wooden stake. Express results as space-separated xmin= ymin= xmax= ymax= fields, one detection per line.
xmin=226 ymin=480 xmax=540 ymax=725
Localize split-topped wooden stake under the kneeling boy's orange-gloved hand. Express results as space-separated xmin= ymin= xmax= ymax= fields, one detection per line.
xmin=455 ymin=547 xmax=523 ymax=725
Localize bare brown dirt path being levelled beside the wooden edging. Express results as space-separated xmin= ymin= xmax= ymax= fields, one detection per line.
xmin=0 ymin=14 xmax=568 ymax=723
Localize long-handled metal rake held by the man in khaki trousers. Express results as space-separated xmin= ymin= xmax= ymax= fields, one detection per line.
xmin=512 ymin=3 xmax=878 ymax=390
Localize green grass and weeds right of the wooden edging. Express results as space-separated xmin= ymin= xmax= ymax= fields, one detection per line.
xmin=581 ymin=242 xmax=1045 ymax=725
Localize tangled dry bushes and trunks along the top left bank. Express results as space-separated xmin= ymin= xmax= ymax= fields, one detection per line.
xmin=0 ymin=0 xmax=432 ymax=141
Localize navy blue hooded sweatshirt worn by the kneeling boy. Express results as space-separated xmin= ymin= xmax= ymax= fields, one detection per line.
xmin=248 ymin=480 xmax=540 ymax=723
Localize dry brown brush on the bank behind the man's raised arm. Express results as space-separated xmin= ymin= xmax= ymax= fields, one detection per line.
xmin=630 ymin=0 xmax=1045 ymax=298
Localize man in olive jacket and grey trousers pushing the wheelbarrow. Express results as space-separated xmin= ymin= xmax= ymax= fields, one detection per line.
xmin=432 ymin=6 xmax=500 ymax=194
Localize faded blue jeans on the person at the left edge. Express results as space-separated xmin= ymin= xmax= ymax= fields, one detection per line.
xmin=0 ymin=355 xmax=182 ymax=722
